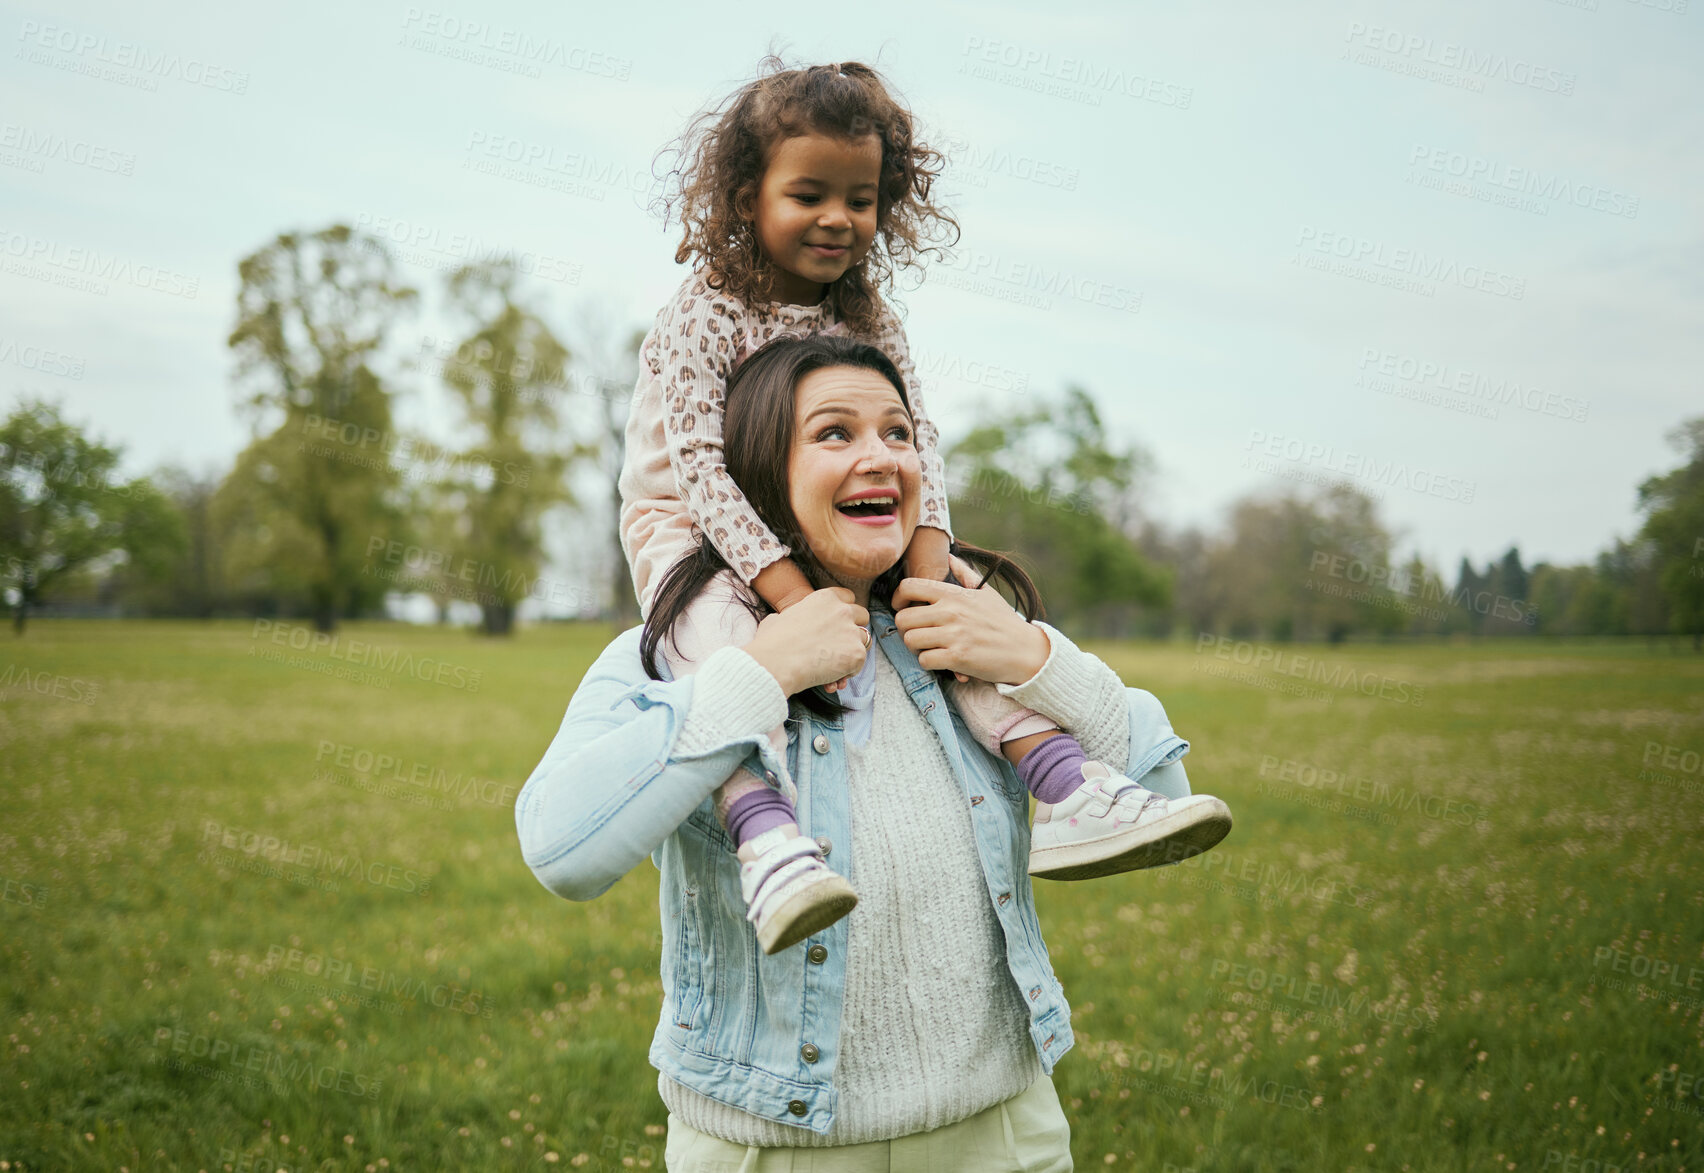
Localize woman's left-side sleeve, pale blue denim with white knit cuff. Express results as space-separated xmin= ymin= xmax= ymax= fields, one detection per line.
xmin=515 ymin=627 xmax=787 ymax=900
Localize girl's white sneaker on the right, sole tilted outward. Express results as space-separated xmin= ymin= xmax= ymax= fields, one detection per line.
xmin=1029 ymin=762 xmax=1230 ymax=880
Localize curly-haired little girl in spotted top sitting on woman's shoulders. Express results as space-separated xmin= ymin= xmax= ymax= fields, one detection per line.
xmin=620 ymin=58 xmax=1230 ymax=953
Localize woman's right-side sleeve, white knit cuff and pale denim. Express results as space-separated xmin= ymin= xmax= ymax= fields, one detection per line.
xmin=995 ymin=619 xmax=1189 ymax=779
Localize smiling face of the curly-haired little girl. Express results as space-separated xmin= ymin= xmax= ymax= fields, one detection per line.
xmin=753 ymin=131 xmax=881 ymax=305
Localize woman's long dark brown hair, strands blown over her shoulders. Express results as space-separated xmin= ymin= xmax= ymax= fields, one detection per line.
xmin=639 ymin=334 xmax=1043 ymax=716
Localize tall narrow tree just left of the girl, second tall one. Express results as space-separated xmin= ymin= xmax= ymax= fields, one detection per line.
xmin=443 ymin=259 xmax=595 ymax=636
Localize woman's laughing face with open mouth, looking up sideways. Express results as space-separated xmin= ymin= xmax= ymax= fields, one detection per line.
xmin=787 ymin=367 xmax=922 ymax=602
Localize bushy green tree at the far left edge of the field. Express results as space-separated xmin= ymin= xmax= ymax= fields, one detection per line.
xmin=0 ymin=399 xmax=184 ymax=636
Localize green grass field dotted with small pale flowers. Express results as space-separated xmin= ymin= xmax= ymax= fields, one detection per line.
xmin=0 ymin=622 xmax=1704 ymax=1173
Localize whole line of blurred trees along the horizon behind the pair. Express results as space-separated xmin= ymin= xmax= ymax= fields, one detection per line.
xmin=0 ymin=223 xmax=1704 ymax=650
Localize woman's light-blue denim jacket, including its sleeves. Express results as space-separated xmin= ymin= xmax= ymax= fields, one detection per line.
xmin=516 ymin=605 xmax=1188 ymax=1132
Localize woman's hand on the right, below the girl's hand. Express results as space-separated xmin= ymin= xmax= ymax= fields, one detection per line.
xmin=893 ymin=578 xmax=1051 ymax=684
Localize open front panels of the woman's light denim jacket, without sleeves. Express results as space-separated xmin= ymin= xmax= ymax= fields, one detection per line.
xmin=651 ymin=607 xmax=1072 ymax=1132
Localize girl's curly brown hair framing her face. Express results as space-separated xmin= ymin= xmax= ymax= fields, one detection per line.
xmin=653 ymin=53 xmax=959 ymax=336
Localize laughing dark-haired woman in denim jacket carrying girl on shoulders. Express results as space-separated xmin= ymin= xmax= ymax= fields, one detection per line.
xmin=515 ymin=336 xmax=1189 ymax=1173
